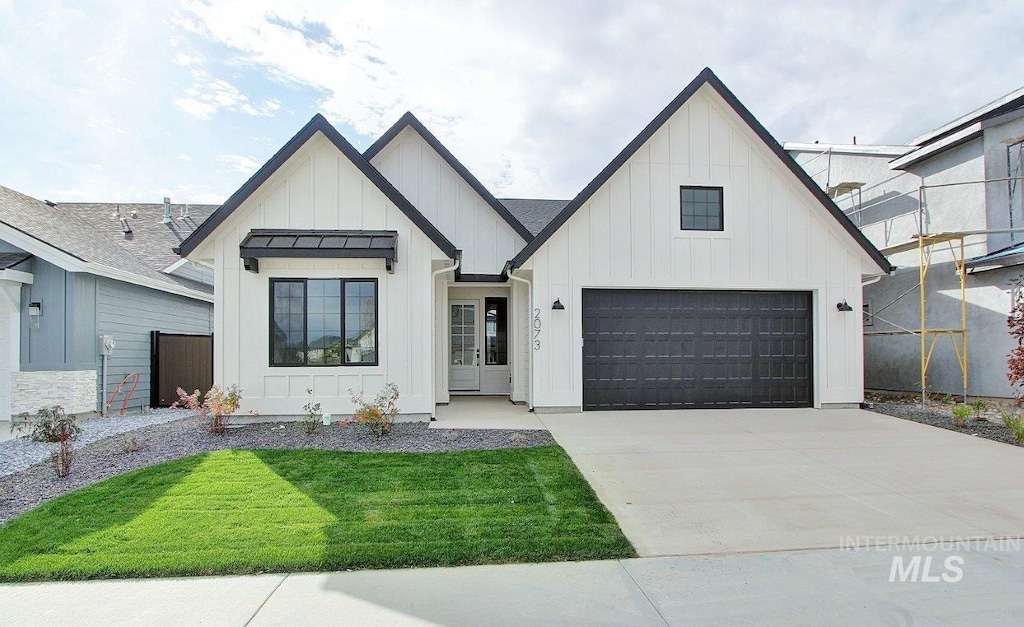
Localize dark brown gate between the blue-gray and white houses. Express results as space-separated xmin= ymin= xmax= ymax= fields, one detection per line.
xmin=150 ymin=331 xmax=213 ymax=407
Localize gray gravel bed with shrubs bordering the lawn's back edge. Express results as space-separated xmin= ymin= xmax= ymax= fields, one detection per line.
xmin=0 ymin=417 xmax=555 ymax=524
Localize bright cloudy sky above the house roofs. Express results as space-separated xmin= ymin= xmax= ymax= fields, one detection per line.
xmin=0 ymin=0 xmax=1024 ymax=203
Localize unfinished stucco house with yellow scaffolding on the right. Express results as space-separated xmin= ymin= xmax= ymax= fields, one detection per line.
xmin=784 ymin=88 xmax=1024 ymax=398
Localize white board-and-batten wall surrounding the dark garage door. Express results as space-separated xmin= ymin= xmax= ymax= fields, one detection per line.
xmin=522 ymin=86 xmax=881 ymax=408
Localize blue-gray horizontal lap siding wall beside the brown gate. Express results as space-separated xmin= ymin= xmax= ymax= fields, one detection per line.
xmin=96 ymin=278 xmax=213 ymax=413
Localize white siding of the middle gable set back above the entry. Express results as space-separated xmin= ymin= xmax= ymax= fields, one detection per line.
xmin=371 ymin=127 xmax=526 ymax=275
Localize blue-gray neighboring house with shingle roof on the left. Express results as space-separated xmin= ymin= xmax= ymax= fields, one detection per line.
xmin=0 ymin=186 xmax=214 ymax=421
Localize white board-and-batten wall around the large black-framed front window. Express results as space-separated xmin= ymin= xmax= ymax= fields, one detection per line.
xmin=190 ymin=133 xmax=446 ymax=417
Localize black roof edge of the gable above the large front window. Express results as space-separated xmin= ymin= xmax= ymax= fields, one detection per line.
xmin=176 ymin=114 xmax=458 ymax=259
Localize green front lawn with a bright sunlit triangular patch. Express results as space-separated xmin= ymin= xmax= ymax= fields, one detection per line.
xmin=0 ymin=447 xmax=635 ymax=581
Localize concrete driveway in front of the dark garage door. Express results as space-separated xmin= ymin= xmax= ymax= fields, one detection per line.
xmin=542 ymin=409 xmax=1024 ymax=556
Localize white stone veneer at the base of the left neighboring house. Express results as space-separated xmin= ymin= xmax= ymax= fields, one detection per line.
xmin=10 ymin=370 xmax=96 ymax=416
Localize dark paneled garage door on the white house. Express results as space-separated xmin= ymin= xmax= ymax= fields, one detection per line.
xmin=583 ymin=290 xmax=811 ymax=410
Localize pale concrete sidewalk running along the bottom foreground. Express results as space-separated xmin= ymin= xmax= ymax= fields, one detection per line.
xmin=0 ymin=541 xmax=1024 ymax=627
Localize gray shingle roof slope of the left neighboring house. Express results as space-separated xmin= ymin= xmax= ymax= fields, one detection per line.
xmin=0 ymin=185 xmax=212 ymax=294
